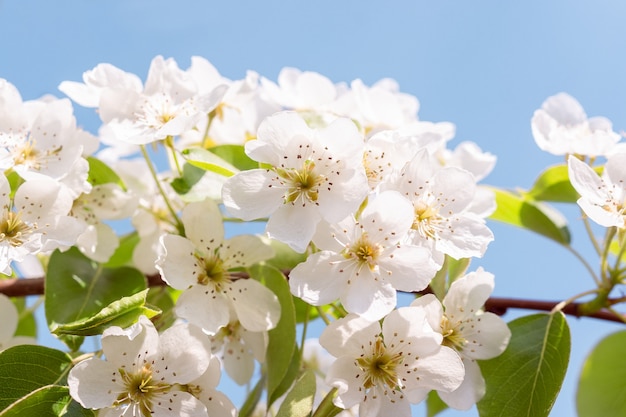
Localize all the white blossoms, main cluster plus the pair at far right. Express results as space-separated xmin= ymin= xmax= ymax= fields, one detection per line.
xmin=0 ymin=56 xmax=580 ymax=416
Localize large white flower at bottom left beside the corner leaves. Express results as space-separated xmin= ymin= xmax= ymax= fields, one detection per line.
xmin=68 ymin=316 xmax=234 ymax=417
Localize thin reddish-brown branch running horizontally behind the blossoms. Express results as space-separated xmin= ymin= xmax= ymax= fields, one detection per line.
xmin=0 ymin=271 xmax=624 ymax=323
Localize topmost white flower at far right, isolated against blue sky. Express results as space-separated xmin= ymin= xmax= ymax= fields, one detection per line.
xmin=531 ymin=93 xmax=620 ymax=156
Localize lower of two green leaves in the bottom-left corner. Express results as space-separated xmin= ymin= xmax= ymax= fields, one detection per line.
xmin=0 ymin=385 xmax=72 ymax=417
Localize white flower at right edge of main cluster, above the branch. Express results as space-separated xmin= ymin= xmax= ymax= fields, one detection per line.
xmin=388 ymin=149 xmax=493 ymax=264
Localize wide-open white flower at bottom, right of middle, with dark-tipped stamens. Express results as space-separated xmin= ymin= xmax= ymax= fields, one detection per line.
xmin=320 ymin=307 xmax=464 ymax=417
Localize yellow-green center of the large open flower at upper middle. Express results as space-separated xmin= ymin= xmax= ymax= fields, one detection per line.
xmin=275 ymin=159 xmax=326 ymax=204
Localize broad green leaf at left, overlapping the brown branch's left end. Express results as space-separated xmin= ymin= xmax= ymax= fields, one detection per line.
xmin=45 ymin=248 xmax=147 ymax=338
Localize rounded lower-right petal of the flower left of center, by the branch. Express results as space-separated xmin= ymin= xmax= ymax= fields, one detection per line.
xmin=229 ymin=278 xmax=280 ymax=332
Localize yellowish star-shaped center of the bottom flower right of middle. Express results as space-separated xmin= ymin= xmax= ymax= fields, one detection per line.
xmin=356 ymin=337 xmax=403 ymax=389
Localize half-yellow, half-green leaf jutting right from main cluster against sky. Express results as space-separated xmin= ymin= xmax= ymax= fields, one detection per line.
xmin=490 ymin=188 xmax=570 ymax=245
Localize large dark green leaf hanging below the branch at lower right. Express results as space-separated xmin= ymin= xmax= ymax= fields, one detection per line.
xmin=478 ymin=312 xmax=571 ymax=417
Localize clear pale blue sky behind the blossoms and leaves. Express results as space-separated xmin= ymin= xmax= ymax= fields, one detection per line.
xmin=0 ymin=0 xmax=626 ymax=417
